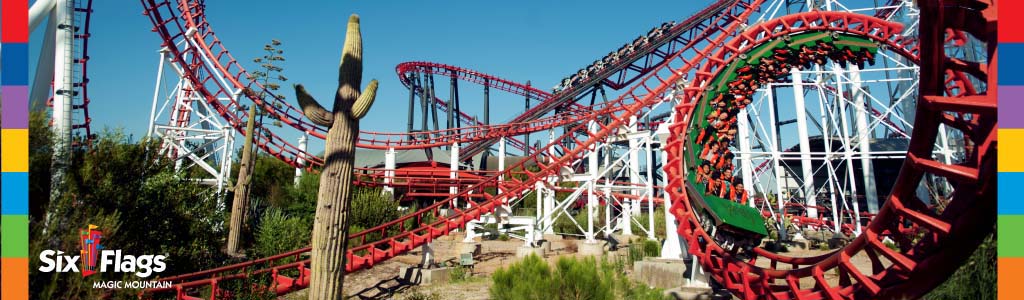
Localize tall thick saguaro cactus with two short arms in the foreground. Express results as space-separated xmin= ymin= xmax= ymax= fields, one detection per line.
xmin=295 ymin=14 xmax=377 ymax=299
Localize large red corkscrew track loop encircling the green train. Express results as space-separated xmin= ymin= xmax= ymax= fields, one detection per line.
xmin=667 ymin=1 xmax=996 ymax=299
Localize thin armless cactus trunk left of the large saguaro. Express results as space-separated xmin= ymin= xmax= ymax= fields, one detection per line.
xmin=226 ymin=104 xmax=256 ymax=256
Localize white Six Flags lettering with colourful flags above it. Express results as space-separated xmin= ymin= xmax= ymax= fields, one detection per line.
xmin=39 ymin=224 xmax=167 ymax=277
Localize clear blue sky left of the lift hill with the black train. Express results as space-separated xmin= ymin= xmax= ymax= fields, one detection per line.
xmin=30 ymin=0 xmax=711 ymax=151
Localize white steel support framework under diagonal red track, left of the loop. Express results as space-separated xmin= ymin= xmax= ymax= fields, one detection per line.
xmin=466 ymin=92 xmax=671 ymax=246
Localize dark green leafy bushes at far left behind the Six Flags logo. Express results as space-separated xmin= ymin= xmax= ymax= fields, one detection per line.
xmin=29 ymin=111 xmax=225 ymax=299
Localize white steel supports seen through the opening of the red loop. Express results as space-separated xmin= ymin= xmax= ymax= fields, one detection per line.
xmin=734 ymin=42 xmax=921 ymax=238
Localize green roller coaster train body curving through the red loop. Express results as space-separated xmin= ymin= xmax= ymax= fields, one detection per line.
xmin=684 ymin=32 xmax=879 ymax=253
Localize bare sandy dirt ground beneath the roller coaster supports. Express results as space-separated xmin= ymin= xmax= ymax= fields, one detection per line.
xmin=281 ymin=233 xmax=870 ymax=300
